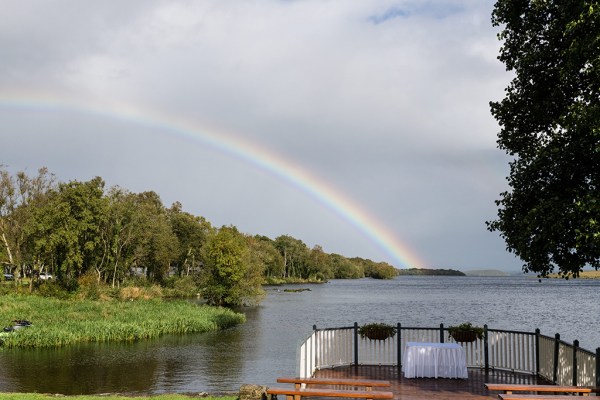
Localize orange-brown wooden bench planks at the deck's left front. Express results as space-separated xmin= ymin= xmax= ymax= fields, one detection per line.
xmin=267 ymin=377 xmax=394 ymax=400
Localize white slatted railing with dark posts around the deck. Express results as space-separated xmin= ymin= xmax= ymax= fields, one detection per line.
xmin=298 ymin=323 xmax=600 ymax=386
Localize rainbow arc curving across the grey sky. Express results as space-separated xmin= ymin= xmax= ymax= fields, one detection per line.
xmin=0 ymin=91 xmax=425 ymax=267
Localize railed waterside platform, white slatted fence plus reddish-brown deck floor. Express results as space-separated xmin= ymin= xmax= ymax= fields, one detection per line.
xmin=297 ymin=323 xmax=600 ymax=400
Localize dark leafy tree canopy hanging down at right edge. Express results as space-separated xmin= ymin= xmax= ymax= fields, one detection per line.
xmin=488 ymin=0 xmax=600 ymax=277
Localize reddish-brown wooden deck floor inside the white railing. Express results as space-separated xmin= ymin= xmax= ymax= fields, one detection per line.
xmin=315 ymin=366 xmax=549 ymax=400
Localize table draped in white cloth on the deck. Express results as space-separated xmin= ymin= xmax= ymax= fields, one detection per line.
xmin=402 ymin=342 xmax=469 ymax=378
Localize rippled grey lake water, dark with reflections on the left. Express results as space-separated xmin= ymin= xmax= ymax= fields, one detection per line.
xmin=0 ymin=277 xmax=600 ymax=394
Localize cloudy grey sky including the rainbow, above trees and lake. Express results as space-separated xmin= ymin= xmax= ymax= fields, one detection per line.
xmin=0 ymin=0 xmax=522 ymax=272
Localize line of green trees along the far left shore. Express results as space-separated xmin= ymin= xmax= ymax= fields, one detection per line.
xmin=0 ymin=166 xmax=397 ymax=305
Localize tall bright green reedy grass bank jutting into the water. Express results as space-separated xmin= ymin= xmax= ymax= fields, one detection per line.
xmin=0 ymin=295 xmax=245 ymax=347
